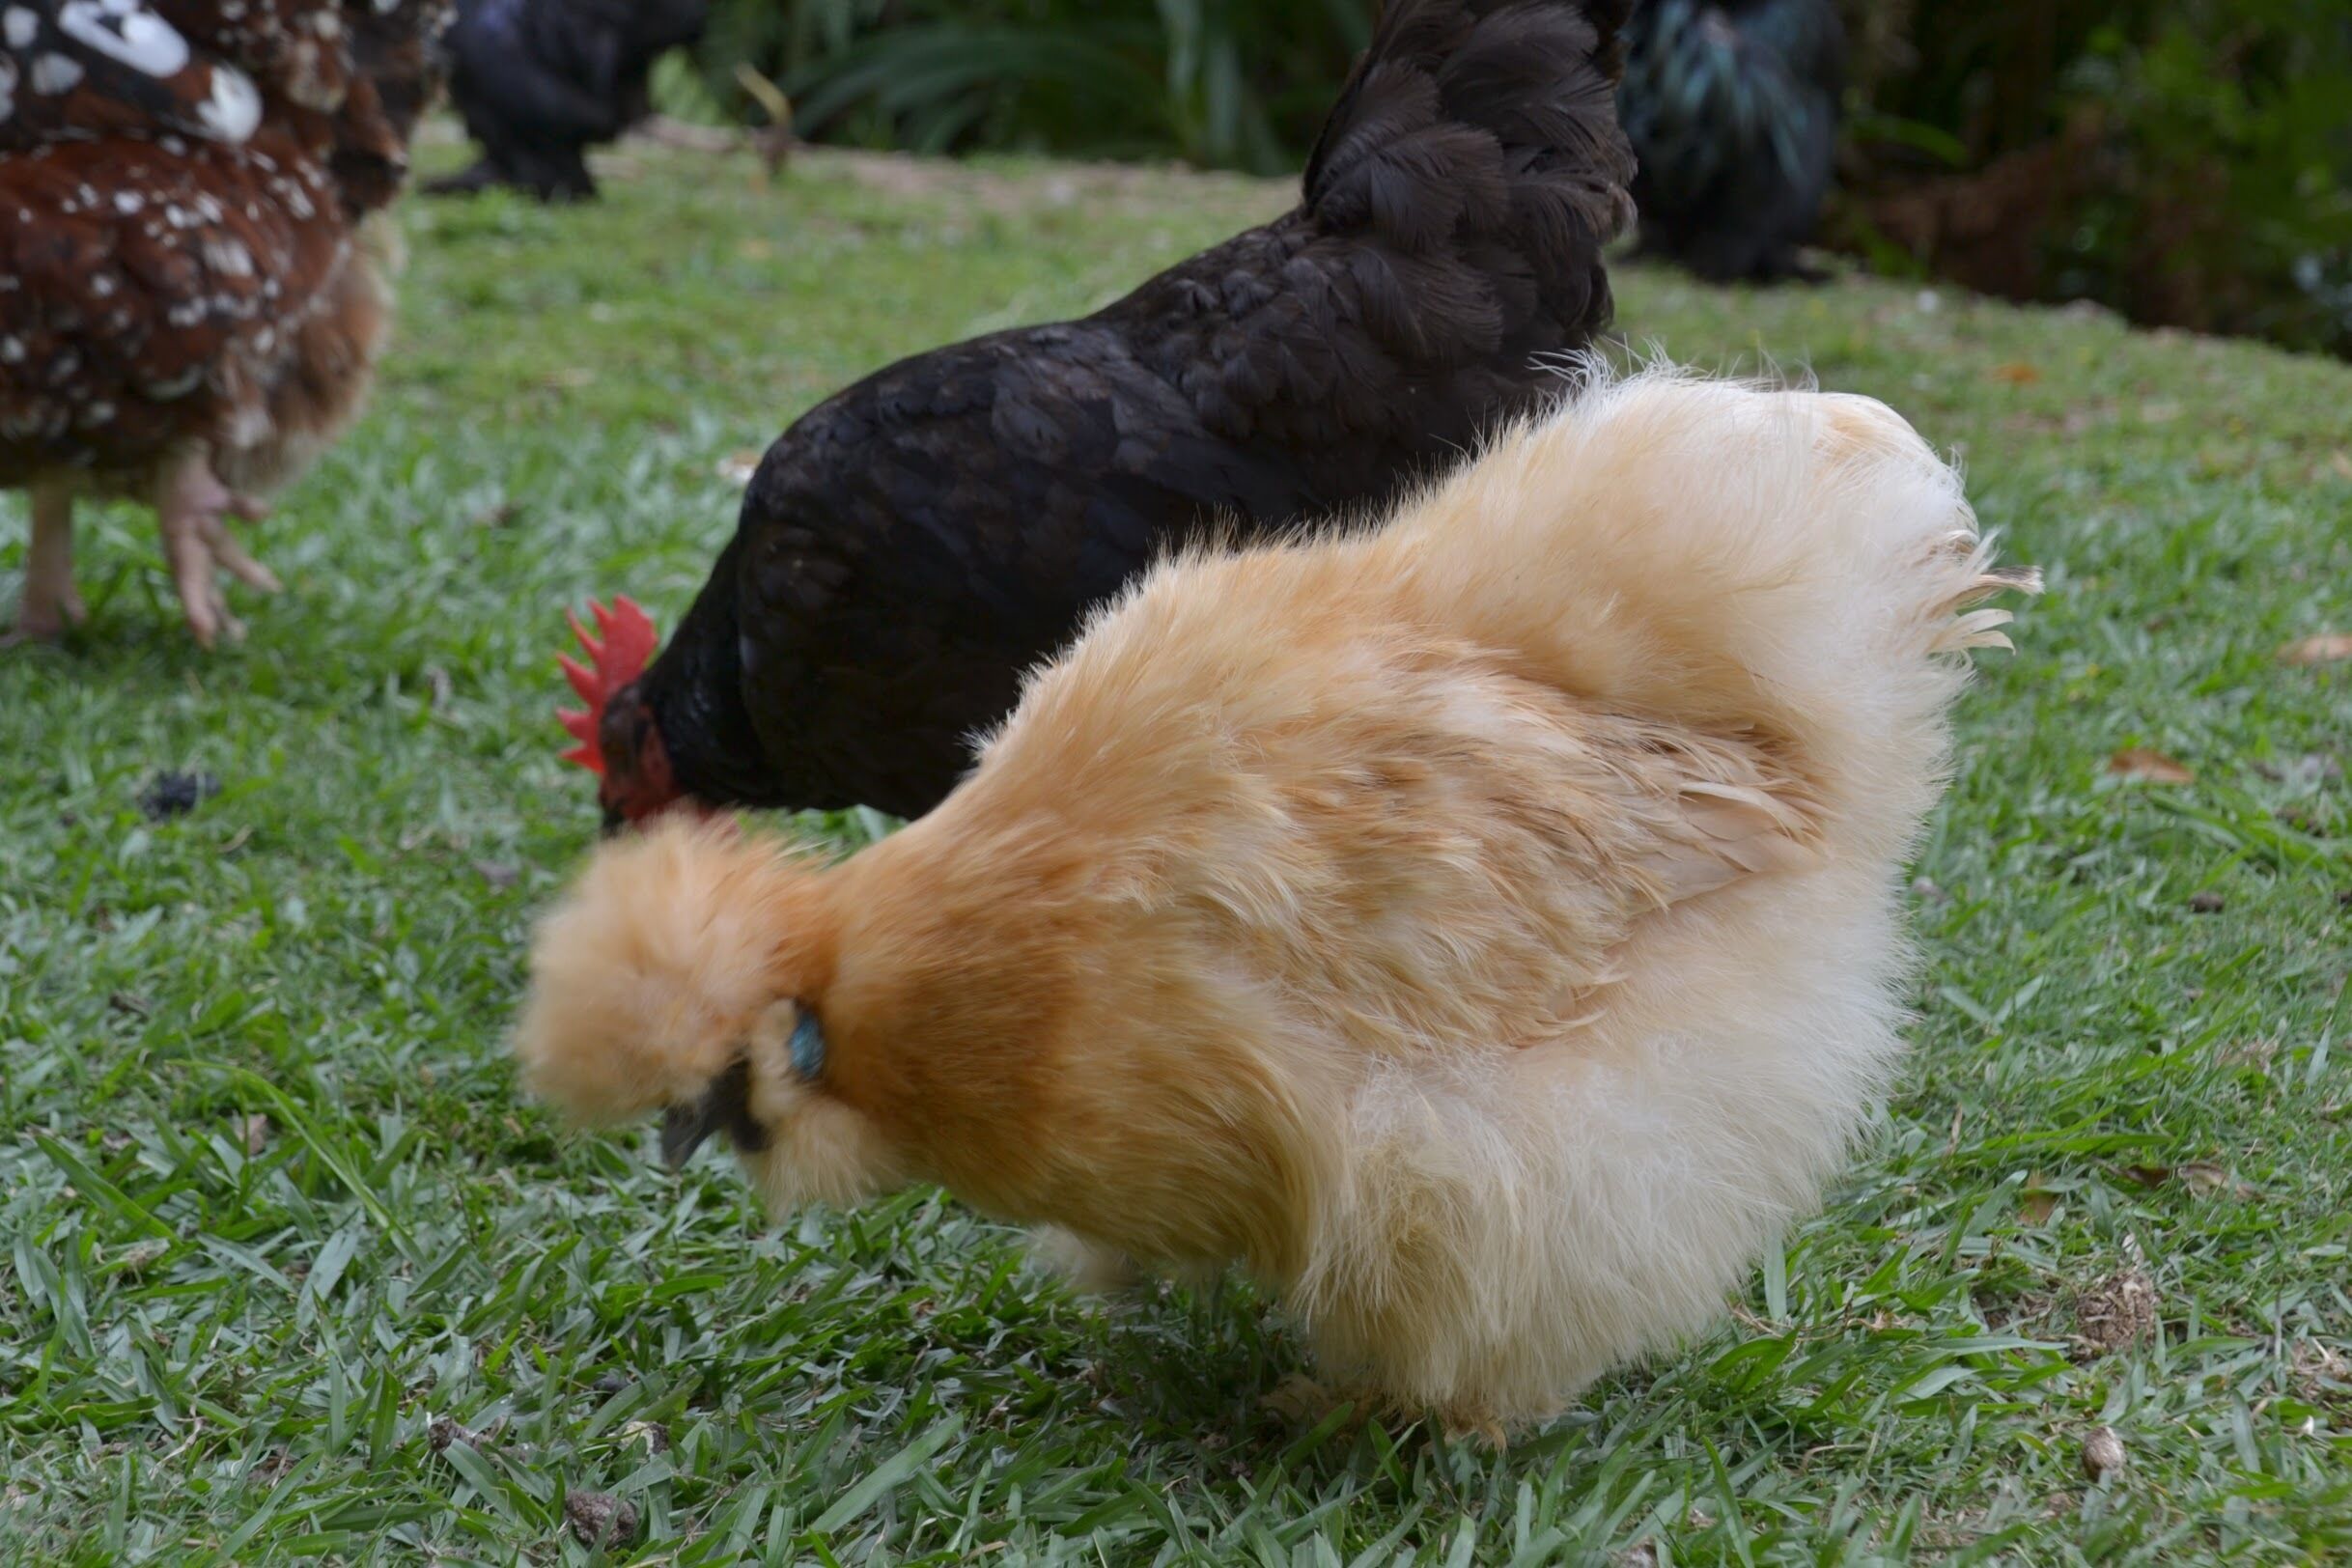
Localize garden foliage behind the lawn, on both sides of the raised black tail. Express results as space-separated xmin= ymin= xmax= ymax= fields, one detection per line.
xmin=665 ymin=0 xmax=2352 ymax=355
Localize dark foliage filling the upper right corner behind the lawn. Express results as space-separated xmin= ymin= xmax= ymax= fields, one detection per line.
xmin=1833 ymin=0 xmax=2352 ymax=352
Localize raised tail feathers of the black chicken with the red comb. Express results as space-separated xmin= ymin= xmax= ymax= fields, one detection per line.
xmin=1305 ymin=0 xmax=1633 ymax=345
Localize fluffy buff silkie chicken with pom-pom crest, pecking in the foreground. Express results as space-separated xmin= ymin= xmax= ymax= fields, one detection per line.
xmin=515 ymin=372 xmax=2034 ymax=1437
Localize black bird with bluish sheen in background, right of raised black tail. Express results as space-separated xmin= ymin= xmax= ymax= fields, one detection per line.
xmin=1618 ymin=0 xmax=1846 ymax=282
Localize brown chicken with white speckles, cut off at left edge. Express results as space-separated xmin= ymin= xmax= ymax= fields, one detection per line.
xmin=0 ymin=0 xmax=447 ymax=647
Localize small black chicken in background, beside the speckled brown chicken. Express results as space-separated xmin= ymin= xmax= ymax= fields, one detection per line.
xmin=426 ymin=0 xmax=708 ymax=202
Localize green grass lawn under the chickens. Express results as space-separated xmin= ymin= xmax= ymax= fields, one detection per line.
xmin=0 ymin=131 xmax=2352 ymax=1566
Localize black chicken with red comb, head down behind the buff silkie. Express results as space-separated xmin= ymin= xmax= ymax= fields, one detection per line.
xmin=567 ymin=0 xmax=1633 ymax=823
